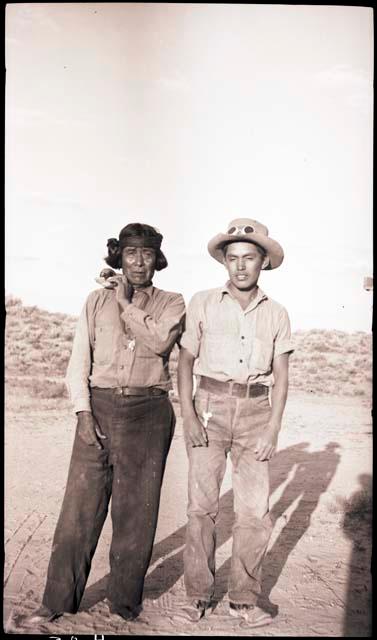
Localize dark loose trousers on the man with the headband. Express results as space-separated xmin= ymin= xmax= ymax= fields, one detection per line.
xmin=43 ymin=389 xmax=175 ymax=613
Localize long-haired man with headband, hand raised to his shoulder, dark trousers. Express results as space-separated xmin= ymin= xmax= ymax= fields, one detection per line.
xmin=27 ymin=223 xmax=185 ymax=625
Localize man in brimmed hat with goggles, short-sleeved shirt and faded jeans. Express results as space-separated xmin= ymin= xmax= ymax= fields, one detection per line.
xmin=178 ymin=218 xmax=293 ymax=627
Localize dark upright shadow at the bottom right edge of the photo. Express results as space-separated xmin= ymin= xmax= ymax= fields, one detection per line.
xmin=342 ymin=473 xmax=372 ymax=638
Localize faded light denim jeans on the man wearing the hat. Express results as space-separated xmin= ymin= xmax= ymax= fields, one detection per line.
xmin=184 ymin=389 xmax=272 ymax=604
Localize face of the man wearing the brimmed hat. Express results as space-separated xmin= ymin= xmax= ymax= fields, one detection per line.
xmin=224 ymin=242 xmax=268 ymax=291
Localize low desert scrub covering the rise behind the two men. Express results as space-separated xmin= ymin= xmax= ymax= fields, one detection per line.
xmin=5 ymin=299 xmax=372 ymax=397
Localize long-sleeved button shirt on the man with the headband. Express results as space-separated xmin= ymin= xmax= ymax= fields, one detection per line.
xmin=65 ymin=286 xmax=185 ymax=412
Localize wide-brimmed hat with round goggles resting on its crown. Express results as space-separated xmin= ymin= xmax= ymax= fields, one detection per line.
xmin=208 ymin=218 xmax=284 ymax=269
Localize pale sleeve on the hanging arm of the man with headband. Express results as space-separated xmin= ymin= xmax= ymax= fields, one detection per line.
xmin=65 ymin=302 xmax=92 ymax=413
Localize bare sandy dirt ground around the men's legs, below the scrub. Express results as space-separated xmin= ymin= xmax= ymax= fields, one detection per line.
xmin=4 ymin=390 xmax=372 ymax=638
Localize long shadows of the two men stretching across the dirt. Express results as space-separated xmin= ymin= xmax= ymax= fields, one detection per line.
xmin=80 ymin=442 xmax=340 ymax=614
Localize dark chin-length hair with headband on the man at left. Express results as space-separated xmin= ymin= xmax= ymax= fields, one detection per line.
xmin=105 ymin=222 xmax=168 ymax=271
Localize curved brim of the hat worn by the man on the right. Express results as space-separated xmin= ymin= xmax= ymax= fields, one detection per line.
xmin=208 ymin=232 xmax=284 ymax=271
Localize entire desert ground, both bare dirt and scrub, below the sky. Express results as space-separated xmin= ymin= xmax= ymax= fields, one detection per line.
xmin=3 ymin=296 xmax=372 ymax=639
